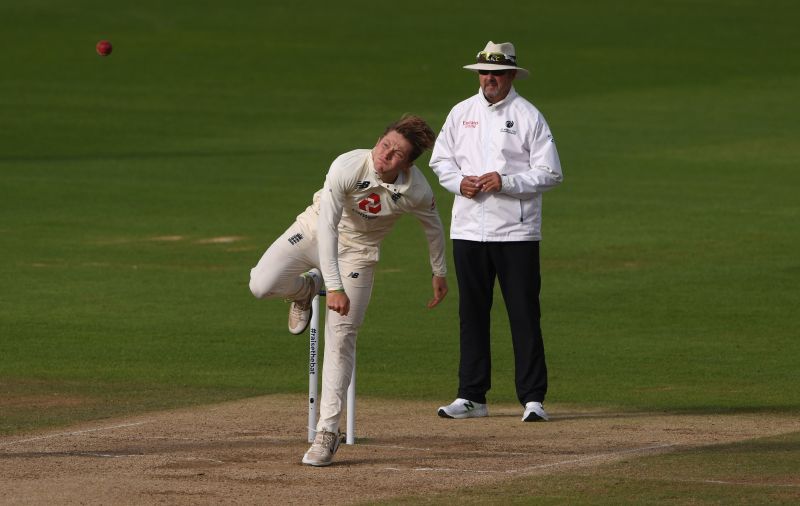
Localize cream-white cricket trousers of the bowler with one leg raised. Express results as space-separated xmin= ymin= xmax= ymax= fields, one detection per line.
xmin=250 ymin=221 xmax=375 ymax=432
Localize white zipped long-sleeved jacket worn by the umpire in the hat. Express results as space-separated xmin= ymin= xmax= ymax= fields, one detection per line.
xmin=430 ymin=87 xmax=563 ymax=242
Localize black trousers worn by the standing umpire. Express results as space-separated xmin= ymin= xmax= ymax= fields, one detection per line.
xmin=453 ymin=239 xmax=547 ymax=405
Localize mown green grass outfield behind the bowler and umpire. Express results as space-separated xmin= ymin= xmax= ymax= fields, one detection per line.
xmin=0 ymin=0 xmax=800 ymax=502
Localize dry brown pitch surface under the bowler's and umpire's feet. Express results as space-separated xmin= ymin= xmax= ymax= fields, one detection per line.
xmin=0 ymin=395 xmax=800 ymax=504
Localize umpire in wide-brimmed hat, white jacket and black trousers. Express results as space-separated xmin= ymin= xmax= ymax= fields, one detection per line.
xmin=430 ymin=41 xmax=563 ymax=422
